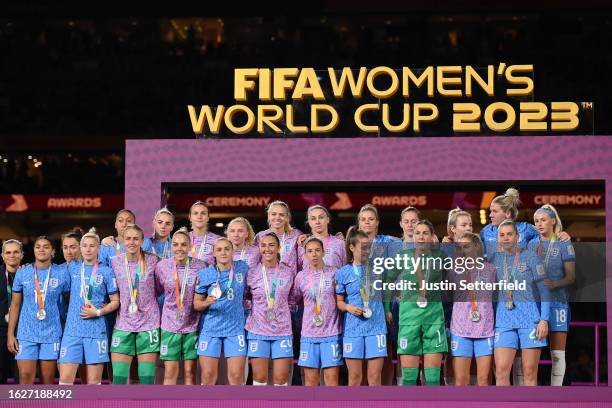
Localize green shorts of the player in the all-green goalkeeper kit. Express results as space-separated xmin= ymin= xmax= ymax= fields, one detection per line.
xmin=397 ymin=323 xmax=448 ymax=356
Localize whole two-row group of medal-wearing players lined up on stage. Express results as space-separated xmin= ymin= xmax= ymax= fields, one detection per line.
xmin=1 ymin=188 xmax=576 ymax=386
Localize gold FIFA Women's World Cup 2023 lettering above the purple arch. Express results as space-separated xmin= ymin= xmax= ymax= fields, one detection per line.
xmin=187 ymin=63 xmax=592 ymax=136
